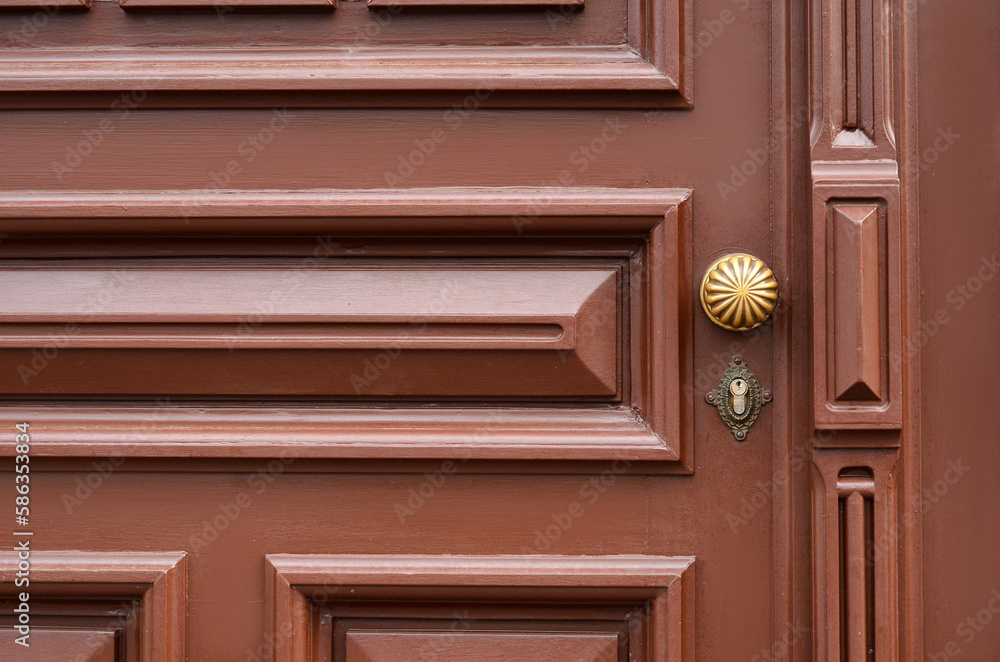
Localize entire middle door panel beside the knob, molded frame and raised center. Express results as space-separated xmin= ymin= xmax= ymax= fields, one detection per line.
xmin=0 ymin=188 xmax=693 ymax=472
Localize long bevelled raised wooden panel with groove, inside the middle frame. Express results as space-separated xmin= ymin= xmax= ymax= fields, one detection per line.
xmin=0 ymin=260 xmax=622 ymax=401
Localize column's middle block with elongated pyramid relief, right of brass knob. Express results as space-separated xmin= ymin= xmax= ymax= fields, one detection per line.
xmin=813 ymin=182 xmax=912 ymax=429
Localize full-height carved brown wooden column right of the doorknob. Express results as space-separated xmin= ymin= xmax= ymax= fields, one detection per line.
xmin=810 ymin=0 xmax=919 ymax=662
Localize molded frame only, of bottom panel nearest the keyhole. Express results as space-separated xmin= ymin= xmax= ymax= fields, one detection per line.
xmin=265 ymin=554 xmax=695 ymax=662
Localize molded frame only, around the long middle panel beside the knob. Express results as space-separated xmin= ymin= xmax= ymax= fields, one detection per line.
xmin=0 ymin=187 xmax=693 ymax=473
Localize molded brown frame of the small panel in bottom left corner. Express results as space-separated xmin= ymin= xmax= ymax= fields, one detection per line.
xmin=0 ymin=550 xmax=187 ymax=662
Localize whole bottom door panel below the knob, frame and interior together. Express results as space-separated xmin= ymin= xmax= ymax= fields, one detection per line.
xmin=266 ymin=554 xmax=695 ymax=662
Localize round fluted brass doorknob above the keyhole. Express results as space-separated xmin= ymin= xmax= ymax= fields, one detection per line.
xmin=701 ymin=253 xmax=778 ymax=331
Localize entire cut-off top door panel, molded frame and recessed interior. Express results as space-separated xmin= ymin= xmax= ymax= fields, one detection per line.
xmin=0 ymin=0 xmax=692 ymax=104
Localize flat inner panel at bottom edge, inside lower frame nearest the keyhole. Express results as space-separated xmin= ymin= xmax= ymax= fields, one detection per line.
xmin=343 ymin=630 xmax=618 ymax=662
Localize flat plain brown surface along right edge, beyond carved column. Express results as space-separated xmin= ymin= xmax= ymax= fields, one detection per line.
xmin=912 ymin=3 xmax=1000 ymax=661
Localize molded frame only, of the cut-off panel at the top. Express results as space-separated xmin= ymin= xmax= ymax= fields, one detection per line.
xmin=0 ymin=0 xmax=693 ymax=107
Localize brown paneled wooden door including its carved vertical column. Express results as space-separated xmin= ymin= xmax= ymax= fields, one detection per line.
xmin=0 ymin=0 xmax=920 ymax=662
